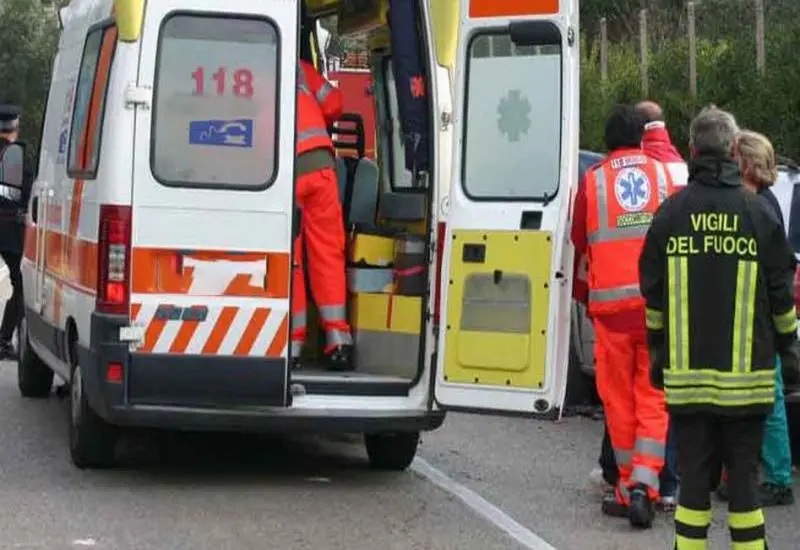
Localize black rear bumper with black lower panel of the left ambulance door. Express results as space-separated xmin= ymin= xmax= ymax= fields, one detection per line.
xmin=78 ymin=313 xmax=444 ymax=433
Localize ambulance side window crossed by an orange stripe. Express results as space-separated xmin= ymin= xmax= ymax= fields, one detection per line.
xmin=67 ymin=27 xmax=117 ymax=179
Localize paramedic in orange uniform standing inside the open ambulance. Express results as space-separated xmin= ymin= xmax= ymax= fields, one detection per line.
xmin=291 ymin=59 xmax=352 ymax=370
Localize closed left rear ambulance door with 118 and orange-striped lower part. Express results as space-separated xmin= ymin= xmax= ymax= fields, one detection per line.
xmin=128 ymin=0 xmax=299 ymax=406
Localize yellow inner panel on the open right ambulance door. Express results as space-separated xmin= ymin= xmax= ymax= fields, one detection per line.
xmin=444 ymin=231 xmax=552 ymax=389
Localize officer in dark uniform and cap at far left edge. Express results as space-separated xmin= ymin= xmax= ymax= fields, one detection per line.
xmin=0 ymin=104 xmax=31 ymax=359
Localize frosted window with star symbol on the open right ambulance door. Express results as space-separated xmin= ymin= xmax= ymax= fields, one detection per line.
xmin=462 ymin=33 xmax=562 ymax=200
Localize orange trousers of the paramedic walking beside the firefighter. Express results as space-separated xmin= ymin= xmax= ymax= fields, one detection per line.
xmin=594 ymin=312 xmax=669 ymax=504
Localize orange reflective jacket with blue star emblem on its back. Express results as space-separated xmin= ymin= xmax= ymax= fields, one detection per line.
xmin=586 ymin=149 xmax=675 ymax=315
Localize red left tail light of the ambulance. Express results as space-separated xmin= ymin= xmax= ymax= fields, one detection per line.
xmin=95 ymin=204 xmax=131 ymax=314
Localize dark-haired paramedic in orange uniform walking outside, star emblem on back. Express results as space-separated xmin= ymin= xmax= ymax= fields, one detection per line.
xmin=572 ymin=105 xmax=673 ymax=527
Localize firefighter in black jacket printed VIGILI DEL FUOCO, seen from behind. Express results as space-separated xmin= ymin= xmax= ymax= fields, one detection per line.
xmin=639 ymin=107 xmax=798 ymax=550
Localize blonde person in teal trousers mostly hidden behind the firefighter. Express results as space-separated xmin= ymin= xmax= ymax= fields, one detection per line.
xmin=717 ymin=130 xmax=794 ymax=506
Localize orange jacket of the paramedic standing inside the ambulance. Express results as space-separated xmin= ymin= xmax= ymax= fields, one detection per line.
xmin=296 ymin=60 xmax=342 ymax=156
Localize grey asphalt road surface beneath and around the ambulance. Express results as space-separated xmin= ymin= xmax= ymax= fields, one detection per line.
xmin=0 ymin=280 xmax=800 ymax=550
